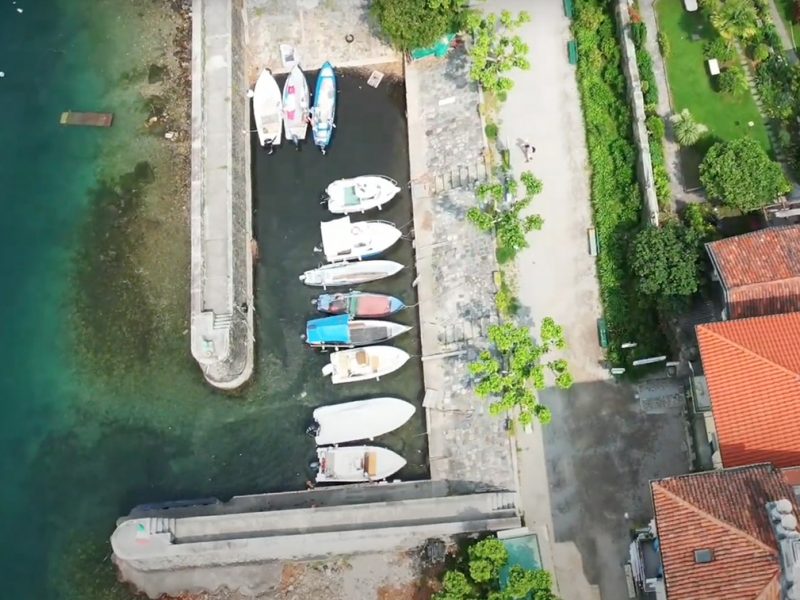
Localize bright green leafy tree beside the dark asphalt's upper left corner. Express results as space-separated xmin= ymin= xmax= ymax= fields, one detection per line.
xmin=469 ymin=317 xmax=572 ymax=425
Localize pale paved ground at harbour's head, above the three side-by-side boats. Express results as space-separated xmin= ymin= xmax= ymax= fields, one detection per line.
xmin=247 ymin=0 xmax=400 ymax=82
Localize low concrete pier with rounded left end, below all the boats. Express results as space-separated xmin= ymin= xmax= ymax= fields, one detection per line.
xmin=111 ymin=492 xmax=520 ymax=572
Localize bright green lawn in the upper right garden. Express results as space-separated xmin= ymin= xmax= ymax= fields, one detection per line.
xmin=656 ymin=0 xmax=771 ymax=153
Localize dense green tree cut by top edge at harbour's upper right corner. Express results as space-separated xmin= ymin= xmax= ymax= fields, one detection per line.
xmin=371 ymin=0 xmax=469 ymax=52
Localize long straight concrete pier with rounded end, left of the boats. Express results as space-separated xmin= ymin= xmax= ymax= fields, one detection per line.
xmin=191 ymin=0 xmax=253 ymax=389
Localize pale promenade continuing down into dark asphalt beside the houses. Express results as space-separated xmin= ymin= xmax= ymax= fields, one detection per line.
xmin=485 ymin=0 xmax=687 ymax=600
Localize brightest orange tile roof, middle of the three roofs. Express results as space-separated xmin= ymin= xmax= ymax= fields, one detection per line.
xmin=697 ymin=313 xmax=800 ymax=467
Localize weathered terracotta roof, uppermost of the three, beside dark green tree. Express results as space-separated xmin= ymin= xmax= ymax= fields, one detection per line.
xmin=706 ymin=225 xmax=800 ymax=319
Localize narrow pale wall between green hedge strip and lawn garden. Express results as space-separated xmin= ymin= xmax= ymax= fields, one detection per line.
xmin=615 ymin=0 xmax=658 ymax=225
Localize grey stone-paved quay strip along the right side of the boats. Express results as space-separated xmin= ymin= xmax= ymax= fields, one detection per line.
xmin=406 ymin=51 xmax=516 ymax=490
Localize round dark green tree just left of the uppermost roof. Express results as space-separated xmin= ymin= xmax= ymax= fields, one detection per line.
xmin=631 ymin=221 xmax=700 ymax=296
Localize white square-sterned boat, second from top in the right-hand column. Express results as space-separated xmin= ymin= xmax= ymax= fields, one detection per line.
xmin=315 ymin=217 xmax=403 ymax=262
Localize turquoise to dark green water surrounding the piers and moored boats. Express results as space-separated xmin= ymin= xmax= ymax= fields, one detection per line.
xmin=0 ymin=0 xmax=427 ymax=600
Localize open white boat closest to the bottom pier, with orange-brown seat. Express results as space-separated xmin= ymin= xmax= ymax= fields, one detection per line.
xmin=317 ymin=446 xmax=406 ymax=483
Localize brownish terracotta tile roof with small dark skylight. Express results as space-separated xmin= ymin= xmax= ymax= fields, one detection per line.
xmin=650 ymin=464 xmax=800 ymax=600
